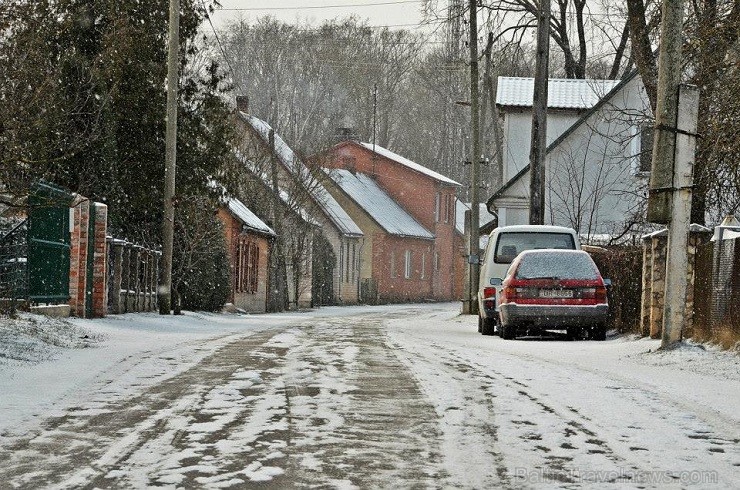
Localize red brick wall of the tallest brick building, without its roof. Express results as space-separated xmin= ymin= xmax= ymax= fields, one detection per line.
xmin=328 ymin=141 xmax=464 ymax=300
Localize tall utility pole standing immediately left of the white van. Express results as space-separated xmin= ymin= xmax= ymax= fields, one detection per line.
xmin=467 ymin=0 xmax=482 ymax=314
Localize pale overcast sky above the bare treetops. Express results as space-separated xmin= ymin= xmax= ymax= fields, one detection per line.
xmin=211 ymin=0 xmax=428 ymax=28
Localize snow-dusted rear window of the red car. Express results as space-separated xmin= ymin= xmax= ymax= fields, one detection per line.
xmin=516 ymin=252 xmax=598 ymax=279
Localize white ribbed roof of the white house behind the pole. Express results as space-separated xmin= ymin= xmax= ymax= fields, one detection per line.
xmin=496 ymin=77 xmax=620 ymax=109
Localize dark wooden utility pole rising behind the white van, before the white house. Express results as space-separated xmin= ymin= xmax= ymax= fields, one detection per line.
xmin=529 ymin=0 xmax=550 ymax=225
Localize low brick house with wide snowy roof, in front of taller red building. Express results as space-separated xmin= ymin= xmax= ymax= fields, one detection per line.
xmin=327 ymin=169 xmax=435 ymax=304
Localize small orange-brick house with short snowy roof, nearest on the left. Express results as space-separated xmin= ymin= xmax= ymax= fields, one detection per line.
xmin=218 ymin=198 xmax=275 ymax=313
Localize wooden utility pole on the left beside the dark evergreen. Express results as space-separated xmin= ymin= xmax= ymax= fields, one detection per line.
xmin=158 ymin=0 xmax=180 ymax=315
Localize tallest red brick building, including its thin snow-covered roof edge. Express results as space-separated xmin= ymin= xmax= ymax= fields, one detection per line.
xmin=315 ymin=140 xmax=465 ymax=300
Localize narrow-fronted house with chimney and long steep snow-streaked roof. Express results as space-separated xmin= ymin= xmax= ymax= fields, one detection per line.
xmin=236 ymin=97 xmax=363 ymax=304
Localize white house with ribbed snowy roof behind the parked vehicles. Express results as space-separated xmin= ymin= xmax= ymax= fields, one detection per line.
xmin=487 ymin=73 xmax=652 ymax=240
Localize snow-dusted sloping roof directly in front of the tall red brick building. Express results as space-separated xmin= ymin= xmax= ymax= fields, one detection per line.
xmin=327 ymin=169 xmax=434 ymax=240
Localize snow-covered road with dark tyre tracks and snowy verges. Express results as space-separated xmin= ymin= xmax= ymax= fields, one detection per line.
xmin=0 ymin=304 xmax=740 ymax=488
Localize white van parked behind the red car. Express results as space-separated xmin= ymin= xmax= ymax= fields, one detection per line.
xmin=478 ymin=225 xmax=581 ymax=335
